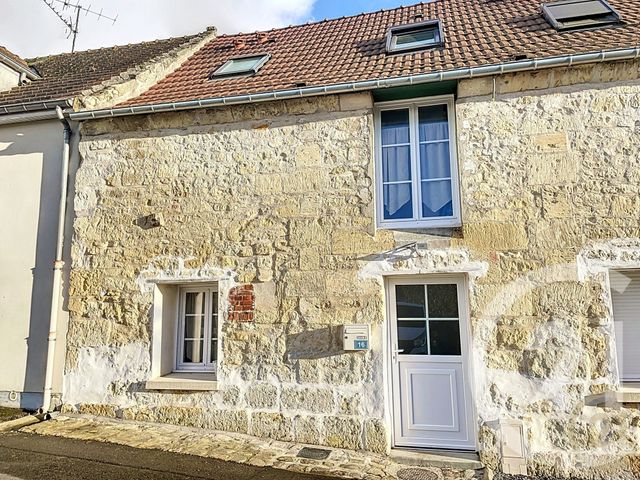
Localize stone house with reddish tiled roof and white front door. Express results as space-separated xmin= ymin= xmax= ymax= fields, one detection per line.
xmin=51 ymin=0 xmax=640 ymax=478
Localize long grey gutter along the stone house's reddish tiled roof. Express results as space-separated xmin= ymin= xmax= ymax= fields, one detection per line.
xmin=69 ymin=47 xmax=640 ymax=121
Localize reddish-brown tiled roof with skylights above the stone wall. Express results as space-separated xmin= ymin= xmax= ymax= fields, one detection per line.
xmin=122 ymin=0 xmax=640 ymax=106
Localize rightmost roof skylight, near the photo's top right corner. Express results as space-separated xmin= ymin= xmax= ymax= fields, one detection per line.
xmin=542 ymin=0 xmax=620 ymax=30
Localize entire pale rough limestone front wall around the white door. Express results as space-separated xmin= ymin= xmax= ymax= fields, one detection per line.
xmin=65 ymin=63 xmax=640 ymax=478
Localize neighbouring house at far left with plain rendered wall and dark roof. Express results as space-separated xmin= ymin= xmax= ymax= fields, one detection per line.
xmin=0 ymin=31 xmax=214 ymax=410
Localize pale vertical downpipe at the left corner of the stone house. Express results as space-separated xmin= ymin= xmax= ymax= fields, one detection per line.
xmin=41 ymin=107 xmax=71 ymax=413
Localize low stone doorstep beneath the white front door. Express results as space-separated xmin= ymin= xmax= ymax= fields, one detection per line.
xmin=390 ymin=448 xmax=484 ymax=470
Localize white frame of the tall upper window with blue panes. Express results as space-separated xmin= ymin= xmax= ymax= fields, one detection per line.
xmin=374 ymin=95 xmax=462 ymax=229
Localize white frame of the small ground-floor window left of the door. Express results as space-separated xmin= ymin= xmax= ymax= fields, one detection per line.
xmin=174 ymin=284 xmax=220 ymax=373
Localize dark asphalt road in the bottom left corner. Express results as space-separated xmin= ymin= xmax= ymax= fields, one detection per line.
xmin=0 ymin=432 xmax=335 ymax=480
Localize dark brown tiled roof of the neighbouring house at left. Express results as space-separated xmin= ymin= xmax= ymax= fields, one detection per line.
xmin=0 ymin=32 xmax=209 ymax=106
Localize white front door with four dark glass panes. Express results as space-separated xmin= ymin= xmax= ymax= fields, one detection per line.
xmin=389 ymin=277 xmax=476 ymax=450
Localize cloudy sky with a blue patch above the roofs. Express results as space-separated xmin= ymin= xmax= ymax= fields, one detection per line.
xmin=5 ymin=0 xmax=402 ymax=58
